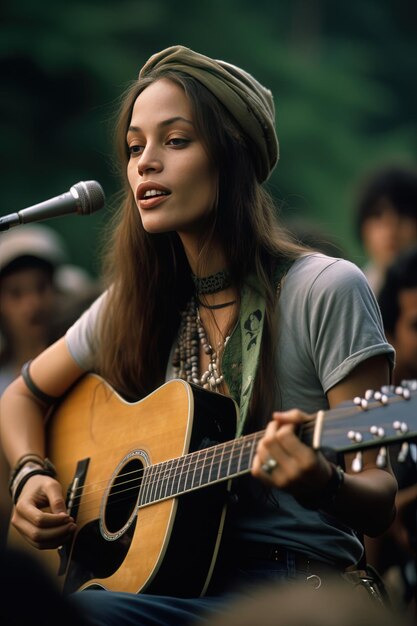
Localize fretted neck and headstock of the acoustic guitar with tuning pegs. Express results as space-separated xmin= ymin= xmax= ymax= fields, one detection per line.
xmin=139 ymin=386 xmax=417 ymax=507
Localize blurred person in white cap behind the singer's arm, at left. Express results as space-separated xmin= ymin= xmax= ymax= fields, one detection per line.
xmin=0 ymin=224 xmax=99 ymax=395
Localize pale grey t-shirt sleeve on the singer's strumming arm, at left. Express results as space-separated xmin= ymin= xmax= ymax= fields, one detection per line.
xmin=65 ymin=291 xmax=108 ymax=372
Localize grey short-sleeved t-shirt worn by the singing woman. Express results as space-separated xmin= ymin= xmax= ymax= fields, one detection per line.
xmin=66 ymin=254 xmax=394 ymax=565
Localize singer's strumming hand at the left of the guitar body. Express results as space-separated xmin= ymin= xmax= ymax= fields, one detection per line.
xmin=11 ymin=475 xmax=76 ymax=550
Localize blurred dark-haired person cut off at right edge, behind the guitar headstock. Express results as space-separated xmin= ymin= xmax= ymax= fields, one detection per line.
xmin=367 ymin=245 xmax=417 ymax=618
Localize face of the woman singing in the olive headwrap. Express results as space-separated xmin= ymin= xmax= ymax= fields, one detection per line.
xmin=127 ymin=79 xmax=217 ymax=236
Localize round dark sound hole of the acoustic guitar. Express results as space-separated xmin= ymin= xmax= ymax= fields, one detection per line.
xmin=105 ymin=458 xmax=143 ymax=533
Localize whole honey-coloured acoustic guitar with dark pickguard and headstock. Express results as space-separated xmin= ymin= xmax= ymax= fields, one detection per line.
xmin=7 ymin=374 xmax=417 ymax=597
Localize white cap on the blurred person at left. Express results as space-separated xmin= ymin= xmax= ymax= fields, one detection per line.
xmin=0 ymin=224 xmax=66 ymax=272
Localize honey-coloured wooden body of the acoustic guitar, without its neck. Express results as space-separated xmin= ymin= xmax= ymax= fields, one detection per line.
xmin=39 ymin=375 xmax=237 ymax=597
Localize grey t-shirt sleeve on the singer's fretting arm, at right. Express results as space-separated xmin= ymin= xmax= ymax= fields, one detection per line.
xmin=306 ymin=259 xmax=394 ymax=392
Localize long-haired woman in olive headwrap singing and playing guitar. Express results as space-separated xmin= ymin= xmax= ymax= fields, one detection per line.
xmin=0 ymin=45 xmax=396 ymax=626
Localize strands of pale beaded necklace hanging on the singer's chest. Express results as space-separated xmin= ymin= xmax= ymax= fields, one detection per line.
xmin=172 ymin=296 xmax=229 ymax=391
